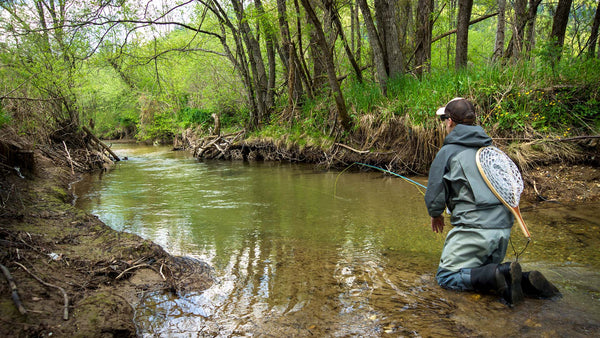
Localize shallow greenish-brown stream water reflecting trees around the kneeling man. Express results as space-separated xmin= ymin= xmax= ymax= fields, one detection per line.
xmin=75 ymin=145 xmax=600 ymax=337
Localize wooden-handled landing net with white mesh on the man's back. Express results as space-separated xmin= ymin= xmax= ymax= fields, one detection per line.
xmin=476 ymin=146 xmax=531 ymax=240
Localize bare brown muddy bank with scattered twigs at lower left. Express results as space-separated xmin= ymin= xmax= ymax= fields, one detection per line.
xmin=0 ymin=152 xmax=212 ymax=337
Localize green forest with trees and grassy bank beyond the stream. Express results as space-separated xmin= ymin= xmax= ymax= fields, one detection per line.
xmin=0 ymin=0 xmax=600 ymax=172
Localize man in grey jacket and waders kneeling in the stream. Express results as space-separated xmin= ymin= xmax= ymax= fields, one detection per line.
xmin=425 ymin=98 xmax=558 ymax=306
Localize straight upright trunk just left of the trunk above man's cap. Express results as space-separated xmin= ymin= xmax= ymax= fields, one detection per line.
xmin=415 ymin=0 xmax=433 ymax=76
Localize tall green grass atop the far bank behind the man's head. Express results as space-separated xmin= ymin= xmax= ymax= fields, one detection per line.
xmin=344 ymin=60 xmax=600 ymax=136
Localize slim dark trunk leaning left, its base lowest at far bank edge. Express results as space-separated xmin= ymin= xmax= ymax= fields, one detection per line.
xmin=302 ymin=0 xmax=352 ymax=130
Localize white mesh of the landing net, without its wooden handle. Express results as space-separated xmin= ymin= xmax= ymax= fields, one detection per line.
xmin=478 ymin=146 xmax=523 ymax=208
